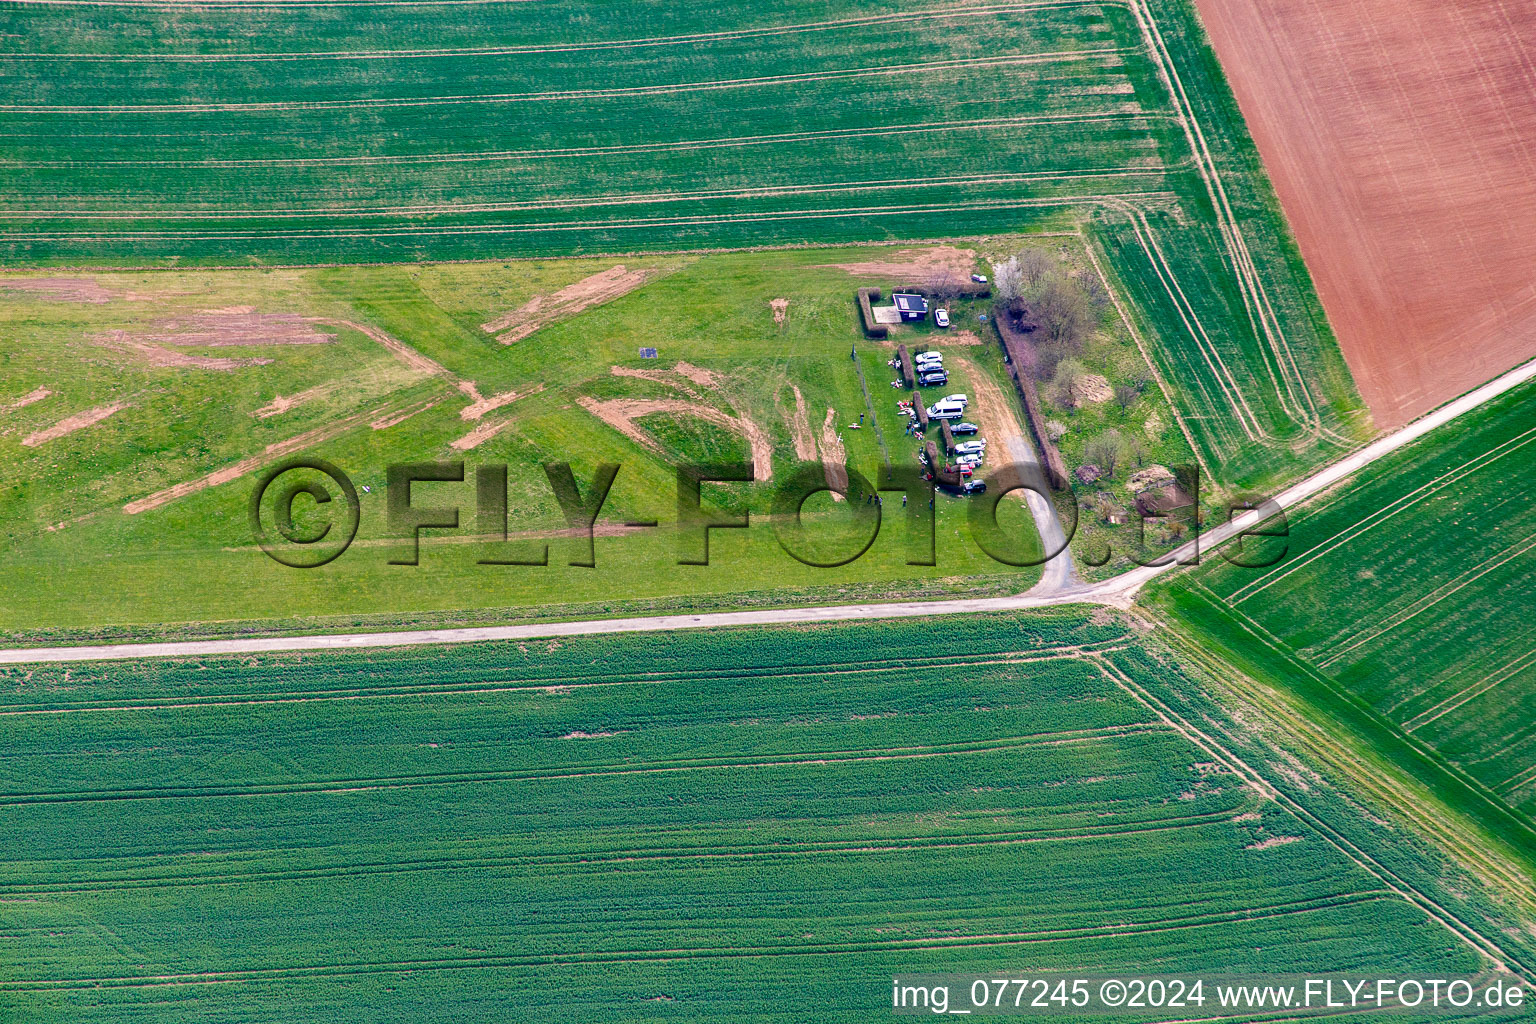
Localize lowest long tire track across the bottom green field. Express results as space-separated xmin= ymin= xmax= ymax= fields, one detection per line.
xmin=0 ymin=890 xmax=1393 ymax=992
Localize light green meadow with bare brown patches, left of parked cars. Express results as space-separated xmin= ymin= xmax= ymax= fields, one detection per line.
xmin=0 ymin=239 xmax=1056 ymax=636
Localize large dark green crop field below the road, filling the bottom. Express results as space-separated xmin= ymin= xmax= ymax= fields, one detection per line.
xmin=0 ymin=614 xmax=1525 ymax=1022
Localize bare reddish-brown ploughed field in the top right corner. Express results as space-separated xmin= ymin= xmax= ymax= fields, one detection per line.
xmin=1197 ymin=0 xmax=1536 ymax=428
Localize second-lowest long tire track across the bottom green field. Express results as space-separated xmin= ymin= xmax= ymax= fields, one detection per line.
xmin=0 ymin=808 xmax=1233 ymax=897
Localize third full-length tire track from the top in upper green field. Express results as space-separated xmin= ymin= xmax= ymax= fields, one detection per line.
xmin=0 ymin=111 xmax=1169 ymax=170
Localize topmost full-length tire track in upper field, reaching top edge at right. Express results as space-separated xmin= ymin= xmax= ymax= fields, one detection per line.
xmin=0 ymin=0 xmax=1124 ymax=63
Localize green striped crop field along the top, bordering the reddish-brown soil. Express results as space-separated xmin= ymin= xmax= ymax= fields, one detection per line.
xmin=0 ymin=0 xmax=1362 ymax=485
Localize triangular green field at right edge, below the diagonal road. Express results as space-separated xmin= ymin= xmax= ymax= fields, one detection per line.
xmin=1155 ymin=385 xmax=1536 ymax=866
